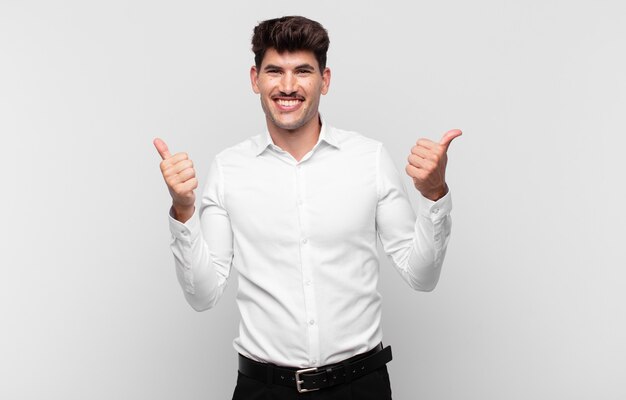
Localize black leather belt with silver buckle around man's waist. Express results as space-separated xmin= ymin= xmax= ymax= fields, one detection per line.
xmin=239 ymin=343 xmax=391 ymax=393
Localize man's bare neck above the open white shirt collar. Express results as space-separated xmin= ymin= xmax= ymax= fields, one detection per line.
xmin=267 ymin=114 xmax=322 ymax=161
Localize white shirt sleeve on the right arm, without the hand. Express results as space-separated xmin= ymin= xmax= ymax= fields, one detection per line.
xmin=376 ymin=144 xmax=452 ymax=291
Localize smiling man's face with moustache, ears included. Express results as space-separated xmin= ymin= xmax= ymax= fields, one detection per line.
xmin=250 ymin=48 xmax=330 ymax=131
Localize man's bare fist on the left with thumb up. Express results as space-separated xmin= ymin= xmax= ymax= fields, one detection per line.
xmin=153 ymin=138 xmax=198 ymax=223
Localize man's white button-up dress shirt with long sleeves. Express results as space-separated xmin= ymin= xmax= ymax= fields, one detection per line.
xmin=170 ymin=122 xmax=452 ymax=368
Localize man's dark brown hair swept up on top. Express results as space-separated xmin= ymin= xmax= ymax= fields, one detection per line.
xmin=252 ymin=16 xmax=330 ymax=73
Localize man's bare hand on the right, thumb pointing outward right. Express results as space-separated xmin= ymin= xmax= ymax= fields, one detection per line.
xmin=406 ymin=129 xmax=462 ymax=201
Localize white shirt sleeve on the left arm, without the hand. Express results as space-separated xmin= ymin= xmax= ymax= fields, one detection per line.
xmin=169 ymin=157 xmax=233 ymax=311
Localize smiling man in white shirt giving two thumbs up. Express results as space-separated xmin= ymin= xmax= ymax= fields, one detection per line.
xmin=154 ymin=17 xmax=461 ymax=400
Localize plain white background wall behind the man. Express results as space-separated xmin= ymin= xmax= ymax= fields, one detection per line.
xmin=0 ymin=0 xmax=626 ymax=400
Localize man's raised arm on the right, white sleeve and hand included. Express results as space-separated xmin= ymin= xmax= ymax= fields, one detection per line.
xmin=376 ymin=130 xmax=460 ymax=291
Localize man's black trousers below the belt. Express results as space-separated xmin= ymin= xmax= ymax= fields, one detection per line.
xmin=233 ymin=365 xmax=391 ymax=400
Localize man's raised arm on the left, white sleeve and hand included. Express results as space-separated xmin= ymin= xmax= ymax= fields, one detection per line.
xmin=154 ymin=139 xmax=233 ymax=311
